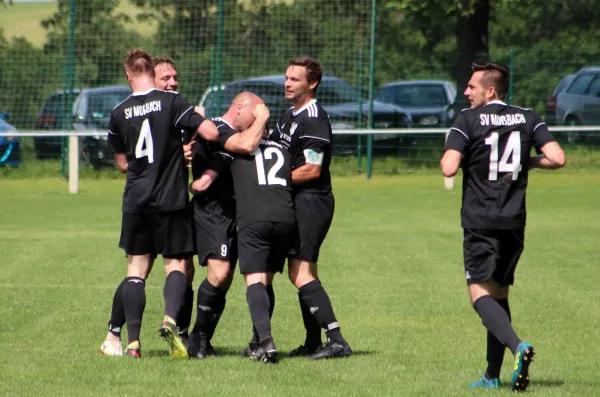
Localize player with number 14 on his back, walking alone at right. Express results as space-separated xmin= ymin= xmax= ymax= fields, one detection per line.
xmin=441 ymin=62 xmax=566 ymax=391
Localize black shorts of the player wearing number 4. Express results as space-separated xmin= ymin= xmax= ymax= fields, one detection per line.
xmin=119 ymin=209 xmax=194 ymax=259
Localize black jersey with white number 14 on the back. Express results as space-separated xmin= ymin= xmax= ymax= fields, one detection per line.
xmin=446 ymin=101 xmax=554 ymax=229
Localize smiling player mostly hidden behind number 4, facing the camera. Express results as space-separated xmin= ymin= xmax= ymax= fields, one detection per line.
xmin=100 ymin=57 xmax=202 ymax=356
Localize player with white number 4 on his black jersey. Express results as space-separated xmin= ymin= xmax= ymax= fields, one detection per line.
xmin=108 ymin=49 xmax=218 ymax=357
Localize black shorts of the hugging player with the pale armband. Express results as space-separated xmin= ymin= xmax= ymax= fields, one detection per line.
xmin=288 ymin=192 xmax=335 ymax=263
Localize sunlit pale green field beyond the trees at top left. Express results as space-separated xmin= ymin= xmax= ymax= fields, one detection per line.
xmin=0 ymin=1 xmax=158 ymax=47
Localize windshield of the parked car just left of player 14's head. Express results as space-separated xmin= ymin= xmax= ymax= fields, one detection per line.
xmin=375 ymin=84 xmax=448 ymax=107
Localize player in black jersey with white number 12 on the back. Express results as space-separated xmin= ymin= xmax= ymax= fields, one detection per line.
xmin=190 ymin=127 xmax=296 ymax=363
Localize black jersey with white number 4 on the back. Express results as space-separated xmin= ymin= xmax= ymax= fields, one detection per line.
xmin=108 ymin=89 xmax=204 ymax=213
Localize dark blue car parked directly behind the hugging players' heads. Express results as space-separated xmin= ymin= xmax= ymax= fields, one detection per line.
xmin=200 ymin=75 xmax=410 ymax=154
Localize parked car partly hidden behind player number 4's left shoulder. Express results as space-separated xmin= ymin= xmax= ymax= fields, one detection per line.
xmin=73 ymin=85 xmax=131 ymax=168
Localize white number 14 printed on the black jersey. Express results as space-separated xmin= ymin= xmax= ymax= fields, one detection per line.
xmin=485 ymin=131 xmax=522 ymax=181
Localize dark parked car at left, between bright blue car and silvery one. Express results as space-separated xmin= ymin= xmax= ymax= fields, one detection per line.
xmin=33 ymin=90 xmax=79 ymax=159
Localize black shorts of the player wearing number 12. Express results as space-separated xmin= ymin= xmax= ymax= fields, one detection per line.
xmin=238 ymin=222 xmax=296 ymax=274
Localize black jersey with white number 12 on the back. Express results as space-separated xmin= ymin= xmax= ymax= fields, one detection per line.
xmin=221 ymin=140 xmax=296 ymax=229
